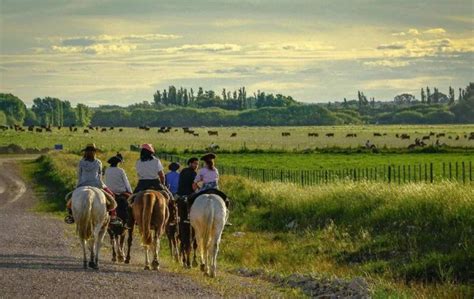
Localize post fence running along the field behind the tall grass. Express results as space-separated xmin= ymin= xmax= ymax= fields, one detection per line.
xmin=160 ymin=154 xmax=474 ymax=186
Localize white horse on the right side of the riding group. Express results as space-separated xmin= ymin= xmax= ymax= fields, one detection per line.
xmin=189 ymin=194 xmax=228 ymax=277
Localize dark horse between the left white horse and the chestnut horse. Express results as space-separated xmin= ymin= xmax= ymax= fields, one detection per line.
xmin=107 ymin=193 xmax=130 ymax=263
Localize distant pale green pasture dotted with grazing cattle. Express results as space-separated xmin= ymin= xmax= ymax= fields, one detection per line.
xmin=0 ymin=125 xmax=474 ymax=152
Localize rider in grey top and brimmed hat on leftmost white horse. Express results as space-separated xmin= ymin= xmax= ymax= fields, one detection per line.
xmin=64 ymin=143 xmax=117 ymax=225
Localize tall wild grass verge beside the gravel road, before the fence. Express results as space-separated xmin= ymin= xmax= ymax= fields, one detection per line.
xmin=21 ymin=153 xmax=474 ymax=298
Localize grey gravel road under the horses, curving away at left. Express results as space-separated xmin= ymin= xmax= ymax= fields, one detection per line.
xmin=0 ymin=159 xmax=216 ymax=298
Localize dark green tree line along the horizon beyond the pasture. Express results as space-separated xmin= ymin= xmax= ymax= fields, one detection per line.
xmin=0 ymin=83 xmax=474 ymax=126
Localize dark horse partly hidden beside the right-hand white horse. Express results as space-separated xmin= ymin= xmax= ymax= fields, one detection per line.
xmin=176 ymin=196 xmax=197 ymax=269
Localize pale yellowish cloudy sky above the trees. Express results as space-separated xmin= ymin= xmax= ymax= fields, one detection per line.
xmin=0 ymin=0 xmax=474 ymax=106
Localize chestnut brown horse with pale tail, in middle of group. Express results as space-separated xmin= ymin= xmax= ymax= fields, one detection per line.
xmin=126 ymin=190 xmax=169 ymax=270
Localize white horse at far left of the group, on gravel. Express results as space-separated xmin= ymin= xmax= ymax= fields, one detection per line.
xmin=71 ymin=187 xmax=113 ymax=269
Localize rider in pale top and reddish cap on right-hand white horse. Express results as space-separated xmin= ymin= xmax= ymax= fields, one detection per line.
xmin=188 ymin=153 xmax=232 ymax=225
